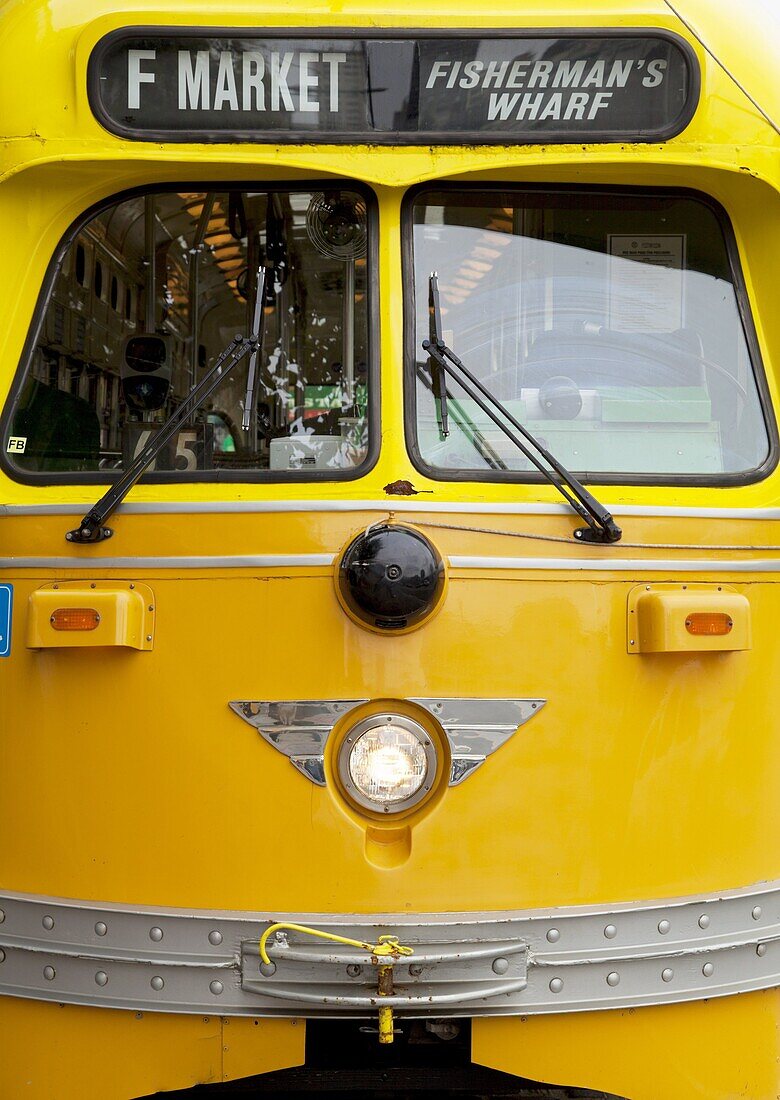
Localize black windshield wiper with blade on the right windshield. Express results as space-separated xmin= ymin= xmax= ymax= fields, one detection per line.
xmin=422 ymin=272 xmax=623 ymax=542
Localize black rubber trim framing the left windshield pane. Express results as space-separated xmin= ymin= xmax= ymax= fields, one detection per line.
xmin=0 ymin=178 xmax=382 ymax=485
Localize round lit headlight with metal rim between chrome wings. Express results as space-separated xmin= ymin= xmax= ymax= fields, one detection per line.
xmin=339 ymin=714 xmax=436 ymax=814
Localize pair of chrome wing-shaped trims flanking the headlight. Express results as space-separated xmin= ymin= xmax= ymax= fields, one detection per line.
xmin=228 ymin=697 xmax=546 ymax=787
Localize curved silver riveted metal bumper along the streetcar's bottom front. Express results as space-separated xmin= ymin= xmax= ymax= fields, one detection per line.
xmin=0 ymin=882 xmax=780 ymax=1018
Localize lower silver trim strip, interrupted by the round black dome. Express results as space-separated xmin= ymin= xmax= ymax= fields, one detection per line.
xmin=0 ymin=554 xmax=780 ymax=576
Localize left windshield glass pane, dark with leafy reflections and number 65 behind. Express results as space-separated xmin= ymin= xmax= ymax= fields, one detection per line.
xmin=9 ymin=187 xmax=371 ymax=480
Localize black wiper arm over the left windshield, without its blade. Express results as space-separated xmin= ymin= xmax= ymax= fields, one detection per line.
xmin=65 ymin=332 xmax=260 ymax=542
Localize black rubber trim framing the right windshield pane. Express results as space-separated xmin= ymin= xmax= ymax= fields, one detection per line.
xmin=400 ymin=180 xmax=780 ymax=487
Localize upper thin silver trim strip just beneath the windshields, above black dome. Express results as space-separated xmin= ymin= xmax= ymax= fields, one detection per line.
xmin=0 ymin=497 xmax=780 ymax=519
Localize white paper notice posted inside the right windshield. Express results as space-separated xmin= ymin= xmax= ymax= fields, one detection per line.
xmin=608 ymin=233 xmax=685 ymax=332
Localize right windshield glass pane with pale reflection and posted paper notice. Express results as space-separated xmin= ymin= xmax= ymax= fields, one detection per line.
xmin=413 ymin=189 xmax=770 ymax=480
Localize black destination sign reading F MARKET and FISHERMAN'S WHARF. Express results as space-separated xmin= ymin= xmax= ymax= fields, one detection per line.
xmin=88 ymin=28 xmax=699 ymax=145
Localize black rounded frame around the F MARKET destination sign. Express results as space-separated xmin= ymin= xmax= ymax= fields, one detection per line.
xmin=87 ymin=24 xmax=701 ymax=146
